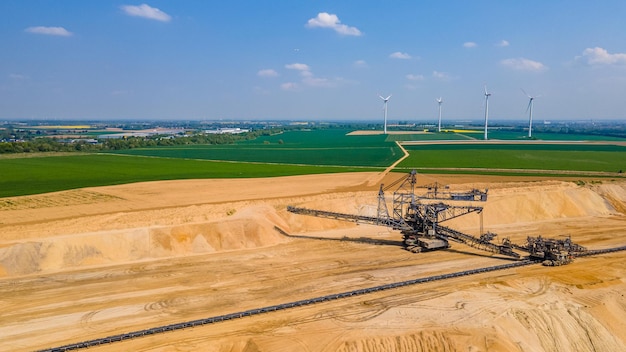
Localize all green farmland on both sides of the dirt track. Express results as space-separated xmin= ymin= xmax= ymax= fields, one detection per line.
xmin=0 ymin=128 xmax=626 ymax=197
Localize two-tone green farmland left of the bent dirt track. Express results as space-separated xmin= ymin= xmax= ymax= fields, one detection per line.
xmin=0 ymin=129 xmax=402 ymax=197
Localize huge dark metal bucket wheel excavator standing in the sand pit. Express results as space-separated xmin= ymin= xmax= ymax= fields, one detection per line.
xmin=287 ymin=170 xmax=585 ymax=265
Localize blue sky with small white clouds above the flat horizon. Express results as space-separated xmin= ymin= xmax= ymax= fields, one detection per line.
xmin=0 ymin=0 xmax=626 ymax=121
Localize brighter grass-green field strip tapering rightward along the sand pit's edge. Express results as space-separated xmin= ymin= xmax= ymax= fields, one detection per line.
xmin=0 ymin=154 xmax=380 ymax=197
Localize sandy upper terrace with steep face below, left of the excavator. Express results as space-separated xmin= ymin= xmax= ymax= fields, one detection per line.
xmin=0 ymin=174 xmax=370 ymax=276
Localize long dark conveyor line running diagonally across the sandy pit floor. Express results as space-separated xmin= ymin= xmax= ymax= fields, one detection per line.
xmin=40 ymin=246 xmax=626 ymax=352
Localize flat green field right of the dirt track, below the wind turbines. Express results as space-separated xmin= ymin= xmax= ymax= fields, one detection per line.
xmin=398 ymin=144 xmax=626 ymax=172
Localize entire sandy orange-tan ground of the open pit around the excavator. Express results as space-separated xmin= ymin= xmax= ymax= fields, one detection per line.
xmin=0 ymin=173 xmax=626 ymax=352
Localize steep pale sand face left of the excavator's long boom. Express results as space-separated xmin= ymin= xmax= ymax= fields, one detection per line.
xmin=0 ymin=206 xmax=287 ymax=276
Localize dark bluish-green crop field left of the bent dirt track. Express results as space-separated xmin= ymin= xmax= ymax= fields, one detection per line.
xmin=106 ymin=129 xmax=403 ymax=167
